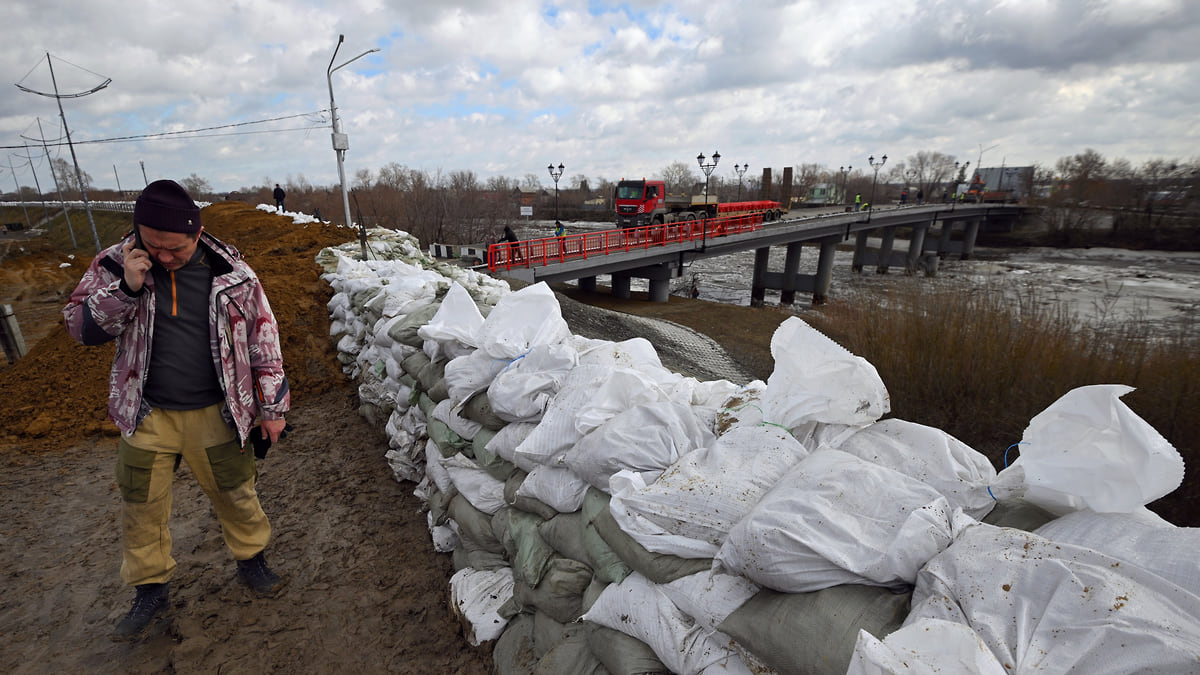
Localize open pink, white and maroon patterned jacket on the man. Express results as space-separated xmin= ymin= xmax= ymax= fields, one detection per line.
xmin=62 ymin=228 xmax=292 ymax=444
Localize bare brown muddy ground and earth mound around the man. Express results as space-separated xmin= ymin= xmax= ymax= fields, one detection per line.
xmin=0 ymin=202 xmax=785 ymax=674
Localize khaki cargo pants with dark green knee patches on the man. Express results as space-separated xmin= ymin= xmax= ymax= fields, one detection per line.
xmin=116 ymin=404 xmax=271 ymax=586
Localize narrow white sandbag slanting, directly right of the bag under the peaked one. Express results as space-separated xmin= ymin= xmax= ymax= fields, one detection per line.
xmin=513 ymin=365 xmax=612 ymax=471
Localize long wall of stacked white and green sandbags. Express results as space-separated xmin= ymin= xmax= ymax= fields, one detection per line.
xmin=318 ymin=231 xmax=1200 ymax=675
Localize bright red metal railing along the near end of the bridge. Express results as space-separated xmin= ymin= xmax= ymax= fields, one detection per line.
xmin=487 ymin=213 xmax=763 ymax=271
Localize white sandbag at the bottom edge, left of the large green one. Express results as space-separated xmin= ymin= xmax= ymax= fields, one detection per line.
xmin=583 ymin=572 xmax=750 ymax=675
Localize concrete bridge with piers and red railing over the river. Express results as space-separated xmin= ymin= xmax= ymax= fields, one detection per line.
xmin=487 ymin=203 xmax=1026 ymax=306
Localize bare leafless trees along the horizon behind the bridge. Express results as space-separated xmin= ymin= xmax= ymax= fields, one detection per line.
xmin=4 ymin=149 xmax=1200 ymax=249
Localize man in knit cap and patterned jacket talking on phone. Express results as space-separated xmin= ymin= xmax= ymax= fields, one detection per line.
xmin=62 ymin=180 xmax=290 ymax=641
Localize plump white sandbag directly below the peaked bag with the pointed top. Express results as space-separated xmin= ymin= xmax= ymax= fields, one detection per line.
xmin=487 ymin=342 xmax=578 ymax=422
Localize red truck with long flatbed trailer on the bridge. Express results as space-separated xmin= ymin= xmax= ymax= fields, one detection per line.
xmin=613 ymin=179 xmax=786 ymax=228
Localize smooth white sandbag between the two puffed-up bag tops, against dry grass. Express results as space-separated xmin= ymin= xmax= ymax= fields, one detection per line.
xmin=836 ymin=419 xmax=996 ymax=520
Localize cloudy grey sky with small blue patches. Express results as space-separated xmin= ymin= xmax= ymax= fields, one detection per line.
xmin=0 ymin=0 xmax=1200 ymax=192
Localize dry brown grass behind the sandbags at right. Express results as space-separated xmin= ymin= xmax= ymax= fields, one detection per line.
xmin=804 ymin=287 xmax=1200 ymax=526
